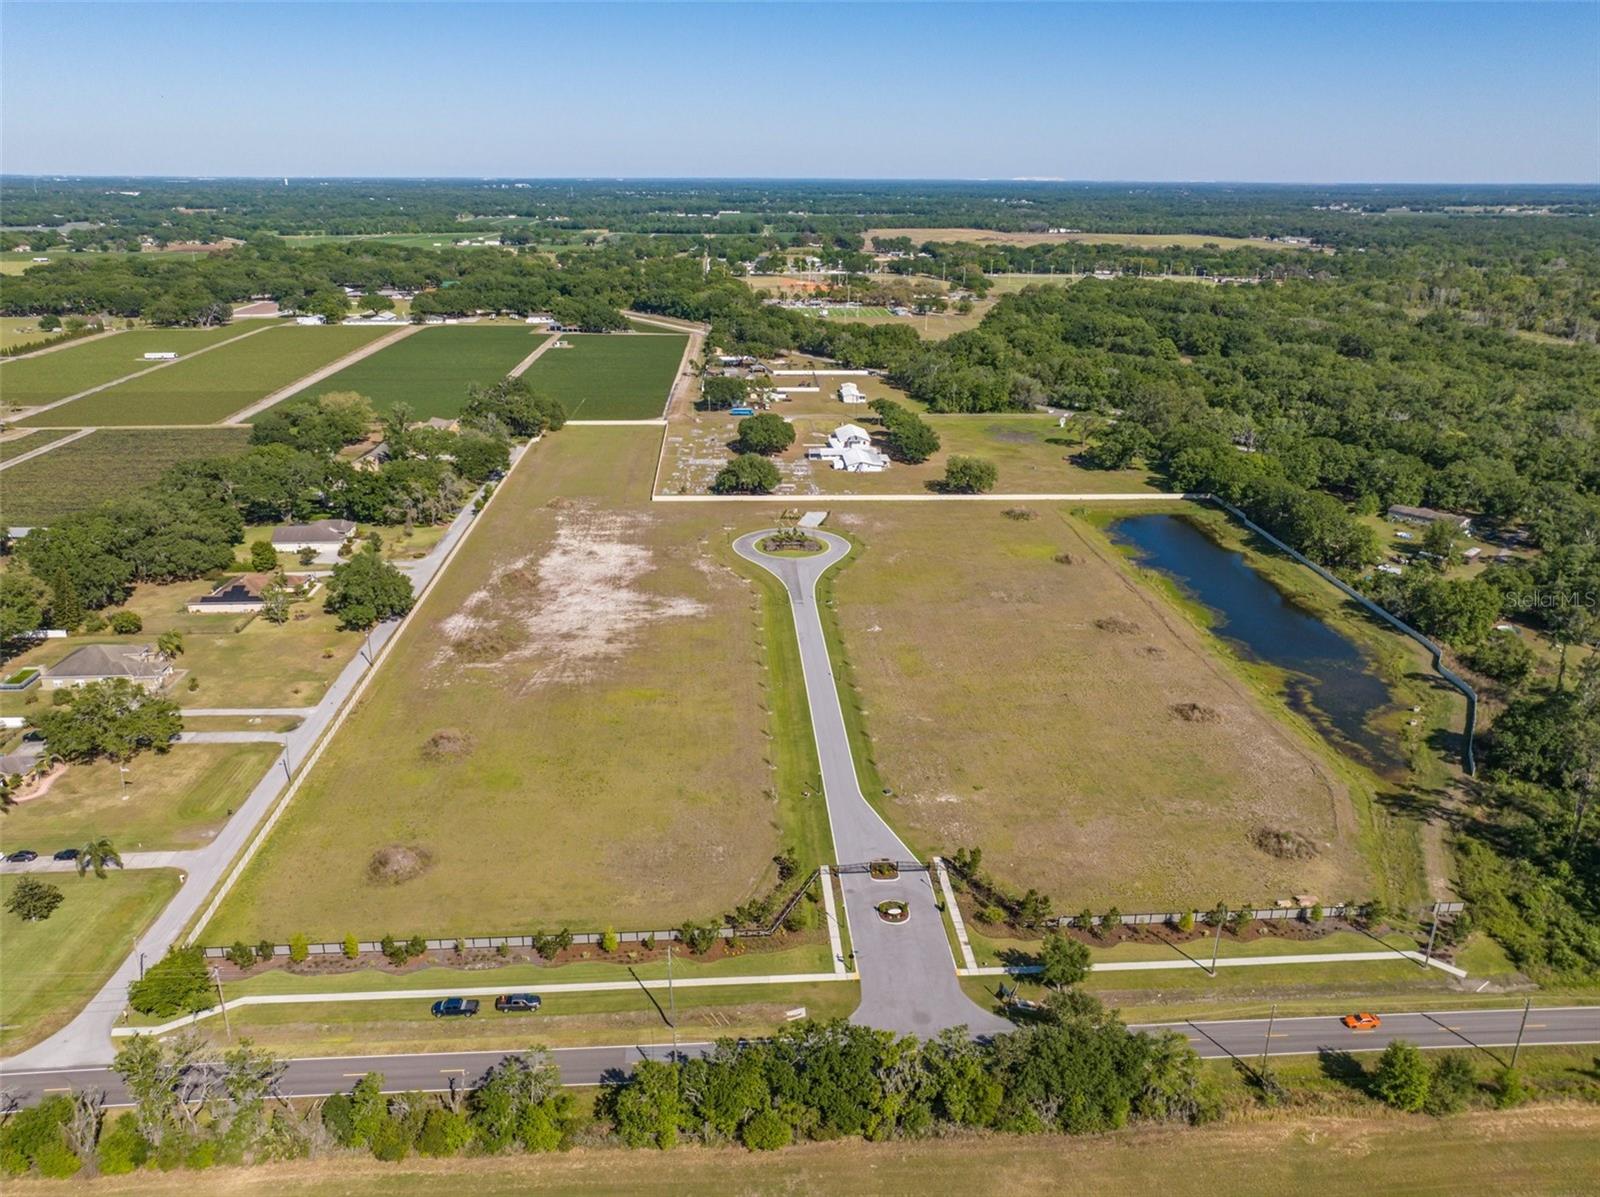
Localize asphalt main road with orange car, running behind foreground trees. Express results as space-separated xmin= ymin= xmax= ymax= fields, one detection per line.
xmin=0 ymin=1007 xmax=1600 ymax=1104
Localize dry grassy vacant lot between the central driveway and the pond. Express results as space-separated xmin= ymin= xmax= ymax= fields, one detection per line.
xmin=824 ymin=504 xmax=1371 ymax=911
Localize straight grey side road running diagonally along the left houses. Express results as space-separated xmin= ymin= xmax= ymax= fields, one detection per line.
xmin=0 ymin=454 xmax=526 ymax=1071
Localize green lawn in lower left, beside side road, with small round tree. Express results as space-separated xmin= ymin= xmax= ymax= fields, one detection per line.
xmin=0 ymin=869 xmax=178 ymax=1055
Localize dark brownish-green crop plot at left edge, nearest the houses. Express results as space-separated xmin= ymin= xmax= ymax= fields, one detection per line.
xmin=0 ymin=428 xmax=250 ymax=528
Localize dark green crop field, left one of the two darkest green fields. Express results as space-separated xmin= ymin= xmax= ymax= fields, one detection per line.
xmin=300 ymin=325 xmax=547 ymax=419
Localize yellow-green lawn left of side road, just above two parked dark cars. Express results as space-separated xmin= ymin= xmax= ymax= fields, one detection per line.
xmin=0 ymin=744 xmax=278 ymax=855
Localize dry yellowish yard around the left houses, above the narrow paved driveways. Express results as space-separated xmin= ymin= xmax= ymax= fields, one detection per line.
xmin=0 ymin=579 xmax=362 ymax=714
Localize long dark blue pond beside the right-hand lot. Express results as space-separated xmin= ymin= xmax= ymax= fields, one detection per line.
xmin=1107 ymin=515 xmax=1406 ymax=775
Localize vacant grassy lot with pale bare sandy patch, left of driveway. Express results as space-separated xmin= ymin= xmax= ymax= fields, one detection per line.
xmin=202 ymin=426 xmax=812 ymax=943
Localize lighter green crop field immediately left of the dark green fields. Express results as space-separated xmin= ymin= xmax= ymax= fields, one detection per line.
xmin=22 ymin=325 xmax=390 ymax=427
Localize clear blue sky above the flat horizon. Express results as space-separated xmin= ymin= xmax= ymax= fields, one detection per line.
xmin=0 ymin=0 xmax=1600 ymax=182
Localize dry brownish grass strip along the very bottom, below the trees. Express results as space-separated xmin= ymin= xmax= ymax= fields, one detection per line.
xmin=10 ymin=1107 xmax=1600 ymax=1197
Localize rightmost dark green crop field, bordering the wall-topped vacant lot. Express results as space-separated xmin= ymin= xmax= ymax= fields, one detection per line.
xmin=523 ymin=333 xmax=688 ymax=419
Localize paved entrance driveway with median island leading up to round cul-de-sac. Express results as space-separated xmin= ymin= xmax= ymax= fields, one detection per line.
xmin=733 ymin=531 xmax=1008 ymax=1035
